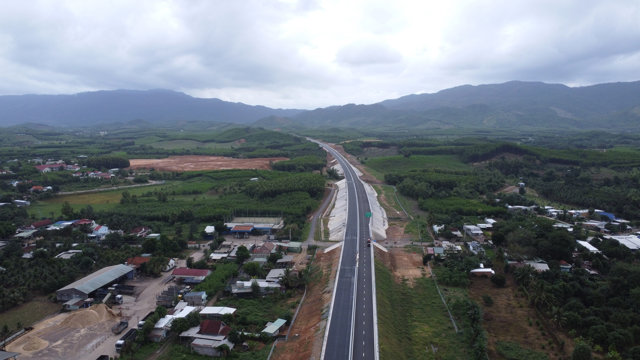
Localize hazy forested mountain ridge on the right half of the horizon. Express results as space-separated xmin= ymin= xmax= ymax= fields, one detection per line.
xmin=294 ymin=81 xmax=640 ymax=131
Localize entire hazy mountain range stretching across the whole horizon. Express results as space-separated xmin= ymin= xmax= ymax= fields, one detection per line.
xmin=0 ymin=81 xmax=640 ymax=131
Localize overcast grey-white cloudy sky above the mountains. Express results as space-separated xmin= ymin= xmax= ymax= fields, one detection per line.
xmin=0 ymin=0 xmax=640 ymax=108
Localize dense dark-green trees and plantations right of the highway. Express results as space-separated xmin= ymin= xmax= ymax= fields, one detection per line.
xmin=344 ymin=133 xmax=640 ymax=359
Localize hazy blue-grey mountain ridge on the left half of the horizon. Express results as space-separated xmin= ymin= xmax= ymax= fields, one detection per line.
xmin=0 ymin=90 xmax=300 ymax=127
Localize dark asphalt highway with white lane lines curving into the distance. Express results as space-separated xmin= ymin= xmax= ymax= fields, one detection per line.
xmin=320 ymin=143 xmax=378 ymax=360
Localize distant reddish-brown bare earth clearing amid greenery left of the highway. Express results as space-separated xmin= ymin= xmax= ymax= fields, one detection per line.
xmin=129 ymin=155 xmax=288 ymax=171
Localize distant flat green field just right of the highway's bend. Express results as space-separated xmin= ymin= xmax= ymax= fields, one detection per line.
xmin=366 ymin=155 xmax=472 ymax=174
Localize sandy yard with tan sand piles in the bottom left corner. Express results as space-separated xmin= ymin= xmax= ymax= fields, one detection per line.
xmin=7 ymin=304 xmax=119 ymax=360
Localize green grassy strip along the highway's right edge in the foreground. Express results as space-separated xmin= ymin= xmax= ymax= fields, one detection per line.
xmin=376 ymin=261 xmax=470 ymax=360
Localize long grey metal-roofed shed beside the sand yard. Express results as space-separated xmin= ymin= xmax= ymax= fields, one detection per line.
xmin=56 ymin=264 xmax=134 ymax=301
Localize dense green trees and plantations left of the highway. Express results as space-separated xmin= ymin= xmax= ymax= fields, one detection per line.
xmin=0 ymin=125 xmax=326 ymax=318
